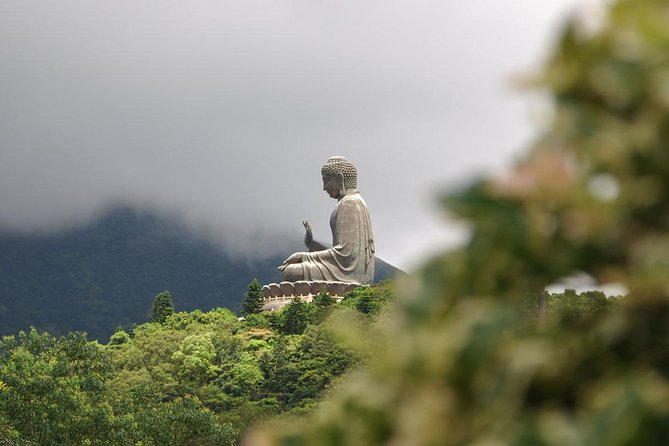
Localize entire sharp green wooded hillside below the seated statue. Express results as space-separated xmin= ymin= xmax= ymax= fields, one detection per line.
xmin=0 ymin=284 xmax=391 ymax=446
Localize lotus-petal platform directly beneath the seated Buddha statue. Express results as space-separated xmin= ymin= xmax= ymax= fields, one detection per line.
xmin=262 ymin=280 xmax=364 ymax=311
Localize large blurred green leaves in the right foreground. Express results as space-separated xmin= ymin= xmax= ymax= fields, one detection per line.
xmin=246 ymin=0 xmax=669 ymax=446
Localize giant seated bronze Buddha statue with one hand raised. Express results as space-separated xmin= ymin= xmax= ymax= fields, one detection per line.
xmin=279 ymin=156 xmax=374 ymax=285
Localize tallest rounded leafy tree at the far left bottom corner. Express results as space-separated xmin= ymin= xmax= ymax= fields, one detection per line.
xmin=0 ymin=329 xmax=118 ymax=445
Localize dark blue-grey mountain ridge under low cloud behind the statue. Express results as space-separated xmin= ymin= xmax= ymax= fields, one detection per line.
xmin=0 ymin=208 xmax=399 ymax=340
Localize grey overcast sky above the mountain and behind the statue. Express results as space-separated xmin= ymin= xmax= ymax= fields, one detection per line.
xmin=0 ymin=0 xmax=593 ymax=269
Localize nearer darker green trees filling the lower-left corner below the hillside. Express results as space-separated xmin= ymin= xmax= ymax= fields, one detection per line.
xmin=0 ymin=329 xmax=235 ymax=446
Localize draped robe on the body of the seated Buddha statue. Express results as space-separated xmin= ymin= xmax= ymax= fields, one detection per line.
xmin=296 ymin=192 xmax=374 ymax=284
